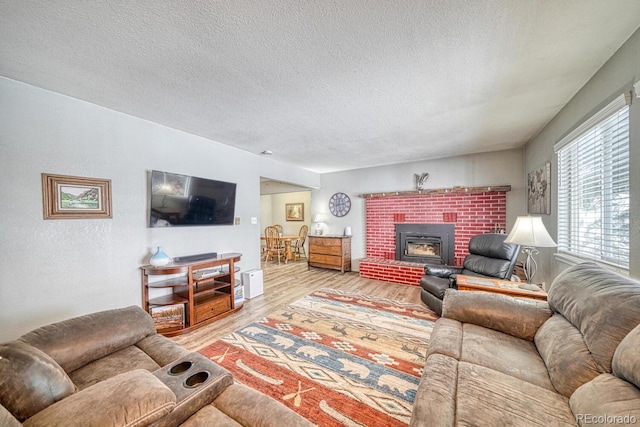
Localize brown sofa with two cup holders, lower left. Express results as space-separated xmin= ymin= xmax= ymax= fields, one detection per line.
xmin=0 ymin=306 xmax=312 ymax=427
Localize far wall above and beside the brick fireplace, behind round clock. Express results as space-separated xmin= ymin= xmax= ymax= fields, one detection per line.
xmin=311 ymin=148 xmax=526 ymax=269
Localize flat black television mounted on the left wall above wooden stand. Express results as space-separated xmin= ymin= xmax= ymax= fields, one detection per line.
xmin=149 ymin=170 xmax=236 ymax=227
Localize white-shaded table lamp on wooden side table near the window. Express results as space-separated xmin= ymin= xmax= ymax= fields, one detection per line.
xmin=504 ymin=216 xmax=557 ymax=290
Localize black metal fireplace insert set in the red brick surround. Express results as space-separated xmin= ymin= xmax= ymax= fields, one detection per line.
xmin=396 ymin=224 xmax=455 ymax=264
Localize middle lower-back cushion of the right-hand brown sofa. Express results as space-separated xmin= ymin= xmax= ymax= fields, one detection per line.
xmin=535 ymin=314 xmax=602 ymax=397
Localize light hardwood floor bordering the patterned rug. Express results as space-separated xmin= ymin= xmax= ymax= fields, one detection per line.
xmin=173 ymin=260 xmax=422 ymax=351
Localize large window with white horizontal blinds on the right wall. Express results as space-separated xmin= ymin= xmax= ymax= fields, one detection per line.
xmin=554 ymin=95 xmax=631 ymax=269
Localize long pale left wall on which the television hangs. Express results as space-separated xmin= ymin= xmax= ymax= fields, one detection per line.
xmin=0 ymin=78 xmax=320 ymax=341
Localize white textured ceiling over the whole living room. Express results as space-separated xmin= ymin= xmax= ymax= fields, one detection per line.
xmin=0 ymin=0 xmax=640 ymax=172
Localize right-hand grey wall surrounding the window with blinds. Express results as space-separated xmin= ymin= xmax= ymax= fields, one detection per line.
xmin=525 ymin=25 xmax=640 ymax=280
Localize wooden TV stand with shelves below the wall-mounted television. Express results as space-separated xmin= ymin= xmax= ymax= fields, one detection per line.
xmin=141 ymin=253 xmax=242 ymax=337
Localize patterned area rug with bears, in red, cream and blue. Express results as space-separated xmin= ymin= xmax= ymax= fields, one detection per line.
xmin=200 ymin=289 xmax=438 ymax=427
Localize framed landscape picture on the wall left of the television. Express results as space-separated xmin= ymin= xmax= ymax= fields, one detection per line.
xmin=42 ymin=173 xmax=111 ymax=219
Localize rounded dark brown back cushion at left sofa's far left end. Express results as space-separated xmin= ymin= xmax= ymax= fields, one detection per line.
xmin=0 ymin=341 xmax=76 ymax=421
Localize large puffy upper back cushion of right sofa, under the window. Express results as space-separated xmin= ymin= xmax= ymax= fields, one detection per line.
xmin=548 ymin=263 xmax=640 ymax=373
